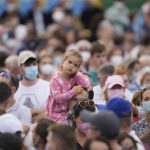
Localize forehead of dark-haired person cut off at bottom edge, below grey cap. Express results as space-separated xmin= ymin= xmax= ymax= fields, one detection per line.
xmin=90 ymin=141 xmax=109 ymax=150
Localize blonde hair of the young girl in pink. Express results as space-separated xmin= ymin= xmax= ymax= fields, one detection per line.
xmin=62 ymin=49 xmax=82 ymax=63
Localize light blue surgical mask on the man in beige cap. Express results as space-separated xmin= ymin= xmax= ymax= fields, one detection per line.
xmin=24 ymin=66 xmax=38 ymax=80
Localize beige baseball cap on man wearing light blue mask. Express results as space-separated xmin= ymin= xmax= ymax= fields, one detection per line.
xmin=18 ymin=50 xmax=37 ymax=65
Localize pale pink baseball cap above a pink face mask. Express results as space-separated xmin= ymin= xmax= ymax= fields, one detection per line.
xmin=105 ymin=75 xmax=125 ymax=89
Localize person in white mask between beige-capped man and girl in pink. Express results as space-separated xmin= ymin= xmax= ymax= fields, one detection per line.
xmin=39 ymin=52 xmax=56 ymax=81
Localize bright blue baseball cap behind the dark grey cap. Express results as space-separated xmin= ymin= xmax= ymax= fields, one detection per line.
xmin=106 ymin=97 xmax=132 ymax=118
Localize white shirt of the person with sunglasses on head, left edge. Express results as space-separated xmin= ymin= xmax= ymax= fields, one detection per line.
xmin=7 ymin=102 xmax=31 ymax=128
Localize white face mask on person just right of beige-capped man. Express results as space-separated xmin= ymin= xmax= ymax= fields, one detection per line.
xmin=40 ymin=64 xmax=54 ymax=75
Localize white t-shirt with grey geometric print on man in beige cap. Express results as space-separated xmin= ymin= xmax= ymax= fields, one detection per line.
xmin=14 ymin=79 xmax=50 ymax=108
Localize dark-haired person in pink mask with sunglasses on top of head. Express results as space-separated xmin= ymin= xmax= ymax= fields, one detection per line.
xmin=72 ymin=99 xmax=95 ymax=150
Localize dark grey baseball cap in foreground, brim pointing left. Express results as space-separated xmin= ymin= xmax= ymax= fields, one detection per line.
xmin=80 ymin=110 xmax=120 ymax=140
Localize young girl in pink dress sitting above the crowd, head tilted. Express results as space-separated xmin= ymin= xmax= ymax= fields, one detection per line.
xmin=46 ymin=50 xmax=90 ymax=124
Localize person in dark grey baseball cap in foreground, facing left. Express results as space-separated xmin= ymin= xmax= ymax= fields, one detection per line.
xmin=80 ymin=110 xmax=122 ymax=150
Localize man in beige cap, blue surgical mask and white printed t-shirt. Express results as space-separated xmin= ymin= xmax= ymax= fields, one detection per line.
xmin=14 ymin=50 xmax=49 ymax=122
